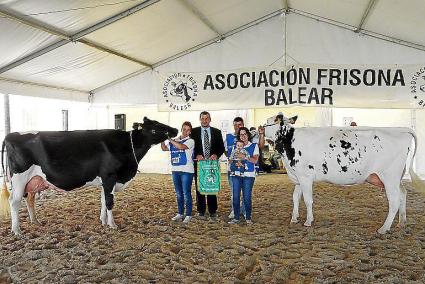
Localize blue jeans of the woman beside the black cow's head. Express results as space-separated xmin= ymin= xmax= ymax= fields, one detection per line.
xmin=172 ymin=171 xmax=193 ymax=216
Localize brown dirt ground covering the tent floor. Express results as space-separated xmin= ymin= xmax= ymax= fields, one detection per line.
xmin=0 ymin=174 xmax=425 ymax=283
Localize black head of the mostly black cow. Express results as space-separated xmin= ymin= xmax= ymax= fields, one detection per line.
xmin=139 ymin=117 xmax=178 ymax=144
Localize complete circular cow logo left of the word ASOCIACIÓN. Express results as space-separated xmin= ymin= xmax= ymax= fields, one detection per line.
xmin=162 ymin=73 xmax=198 ymax=110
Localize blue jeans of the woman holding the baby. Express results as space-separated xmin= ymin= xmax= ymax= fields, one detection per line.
xmin=231 ymin=176 xmax=255 ymax=220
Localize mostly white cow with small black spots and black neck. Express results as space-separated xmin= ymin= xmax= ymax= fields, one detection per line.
xmin=268 ymin=115 xmax=417 ymax=234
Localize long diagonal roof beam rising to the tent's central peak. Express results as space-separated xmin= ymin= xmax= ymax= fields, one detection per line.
xmin=90 ymin=9 xmax=284 ymax=94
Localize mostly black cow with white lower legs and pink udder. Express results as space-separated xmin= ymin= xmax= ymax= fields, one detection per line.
xmin=2 ymin=117 xmax=178 ymax=235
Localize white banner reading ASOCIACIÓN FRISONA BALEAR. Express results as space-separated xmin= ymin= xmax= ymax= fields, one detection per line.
xmin=157 ymin=64 xmax=425 ymax=111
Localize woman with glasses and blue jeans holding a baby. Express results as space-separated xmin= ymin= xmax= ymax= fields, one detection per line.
xmin=229 ymin=127 xmax=259 ymax=225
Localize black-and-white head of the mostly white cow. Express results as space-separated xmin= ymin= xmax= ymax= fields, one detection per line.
xmin=274 ymin=114 xmax=298 ymax=153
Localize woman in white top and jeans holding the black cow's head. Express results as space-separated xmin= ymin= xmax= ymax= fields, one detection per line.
xmin=161 ymin=121 xmax=195 ymax=224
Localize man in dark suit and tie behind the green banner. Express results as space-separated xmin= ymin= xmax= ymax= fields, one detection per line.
xmin=190 ymin=111 xmax=224 ymax=218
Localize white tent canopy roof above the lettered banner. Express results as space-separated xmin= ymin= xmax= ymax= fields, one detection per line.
xmin=0 ymin=0 xmax=425 ymax=100
